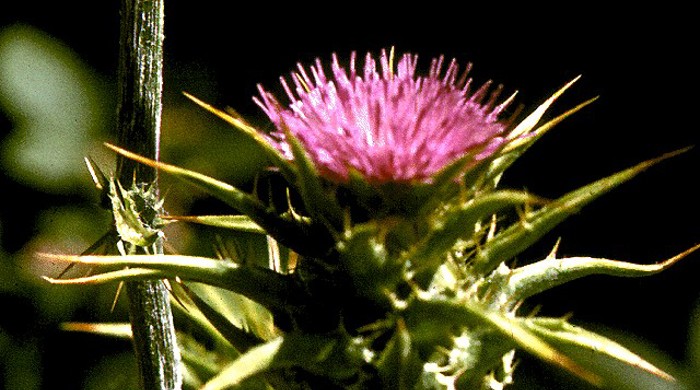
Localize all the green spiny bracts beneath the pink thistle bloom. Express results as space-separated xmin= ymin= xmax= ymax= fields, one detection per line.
xmin=46 ymin=58 xmax=695 ymax=390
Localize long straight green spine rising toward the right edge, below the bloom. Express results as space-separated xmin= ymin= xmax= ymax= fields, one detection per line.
xmin=471 ymin=148 xmax=688 ymax=274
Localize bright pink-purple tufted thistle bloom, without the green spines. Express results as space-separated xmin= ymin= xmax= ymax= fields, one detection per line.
xmin=254 ymin=50 xmax=512 ymax=184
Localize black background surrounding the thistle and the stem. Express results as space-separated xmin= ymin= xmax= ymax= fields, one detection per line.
xmin=0 ymin=1 xmax=700 ymax=388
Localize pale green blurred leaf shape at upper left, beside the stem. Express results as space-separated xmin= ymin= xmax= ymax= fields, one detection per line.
xmin=0 ymin=25 xmax=111 ymax=193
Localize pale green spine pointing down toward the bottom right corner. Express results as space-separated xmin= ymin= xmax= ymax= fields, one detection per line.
xmin=519 ymin=317 xmax=681 ymax=390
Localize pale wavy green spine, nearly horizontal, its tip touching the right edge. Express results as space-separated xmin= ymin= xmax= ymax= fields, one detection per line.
xmin=507 ymin=244 xmax=700 ymax=301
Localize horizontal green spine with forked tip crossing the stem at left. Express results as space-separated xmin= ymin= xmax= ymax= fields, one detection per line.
xmin=39 ymin=254 xmax=302 ymax=311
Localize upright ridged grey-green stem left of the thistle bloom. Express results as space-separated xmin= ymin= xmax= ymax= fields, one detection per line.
xmin=117 ymin=0 xmax=182 ymax=390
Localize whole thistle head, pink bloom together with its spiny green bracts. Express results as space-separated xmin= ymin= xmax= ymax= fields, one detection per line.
xmin=47 ymin=48 xmax=700 ymax=390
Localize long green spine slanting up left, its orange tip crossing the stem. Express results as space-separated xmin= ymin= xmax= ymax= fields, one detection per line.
xmin=105 ymin=144 xmax=332 ymax=255
